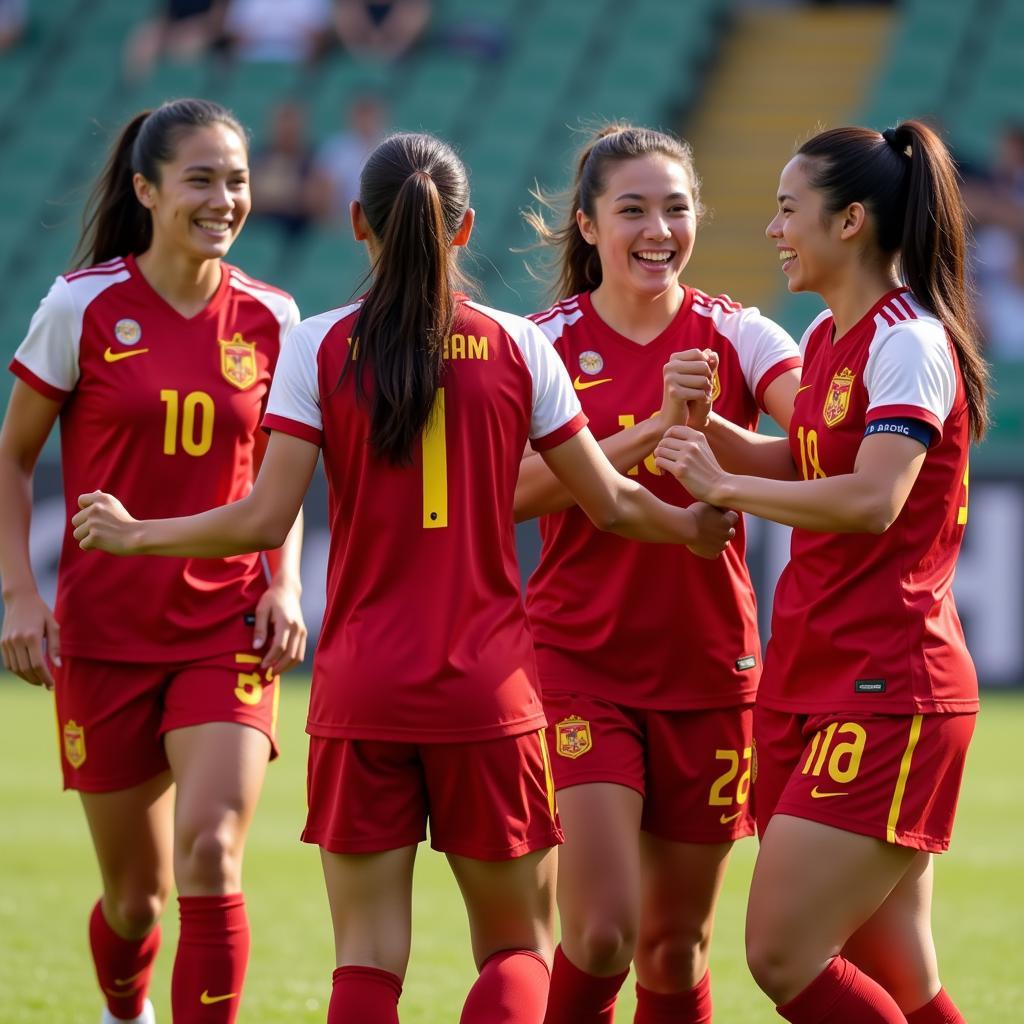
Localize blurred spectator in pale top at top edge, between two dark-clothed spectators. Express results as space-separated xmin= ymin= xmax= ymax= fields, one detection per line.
xmin=224 ymin=0 xmax=334 ymax=63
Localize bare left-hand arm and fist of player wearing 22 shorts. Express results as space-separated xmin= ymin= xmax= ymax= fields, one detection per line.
xmin=515 ymin=349 xmax=714 ymax=522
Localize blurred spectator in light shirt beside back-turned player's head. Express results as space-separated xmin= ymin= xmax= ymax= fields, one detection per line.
xmin=312 ymin=95 xmax=388 ymax=225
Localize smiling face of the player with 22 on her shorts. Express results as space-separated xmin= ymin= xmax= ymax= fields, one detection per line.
xmin=577 ymin=154 xmax=696 ymax=296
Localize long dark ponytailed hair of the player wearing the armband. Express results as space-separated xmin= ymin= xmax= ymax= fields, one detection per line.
xmin=798 ymin=121 xmax=989 ymax=440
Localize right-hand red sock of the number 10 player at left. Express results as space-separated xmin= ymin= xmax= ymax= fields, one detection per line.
xmin=171 ymin=893 xmax=249 ymax=1024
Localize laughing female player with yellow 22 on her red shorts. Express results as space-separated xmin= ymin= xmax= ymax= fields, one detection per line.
xmin=516 ymin=125 xmax=800 ymax=1024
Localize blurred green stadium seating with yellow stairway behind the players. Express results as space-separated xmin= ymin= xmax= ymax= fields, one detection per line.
xmin=0 ymin=0 xmax=1024 ymax=466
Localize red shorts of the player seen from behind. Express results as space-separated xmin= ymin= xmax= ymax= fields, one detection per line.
xmin=302 ymin=729 xmax=562 ymax=860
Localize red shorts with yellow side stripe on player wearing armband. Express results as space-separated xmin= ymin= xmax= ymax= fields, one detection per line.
xmin=754 ymin=707 xmax=976 ymax=853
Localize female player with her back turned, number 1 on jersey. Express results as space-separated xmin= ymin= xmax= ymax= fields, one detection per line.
xmin=74 ymin=134 xmax=735 ymax=1024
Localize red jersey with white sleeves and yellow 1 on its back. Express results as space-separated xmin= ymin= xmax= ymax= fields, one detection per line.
xmin=264 ymin=298 xmax=586 ymax=742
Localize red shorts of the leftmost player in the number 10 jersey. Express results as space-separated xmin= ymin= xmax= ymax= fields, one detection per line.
xmin=54 ymin=651 xmax=281 ymax=793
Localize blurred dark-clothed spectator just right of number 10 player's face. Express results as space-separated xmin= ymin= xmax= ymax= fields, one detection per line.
xmin=249 ymin=100 xmax=313 ymax=247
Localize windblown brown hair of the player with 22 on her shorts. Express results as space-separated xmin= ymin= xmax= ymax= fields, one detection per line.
xmin=523 ymin=123 xmax=701 ymax=301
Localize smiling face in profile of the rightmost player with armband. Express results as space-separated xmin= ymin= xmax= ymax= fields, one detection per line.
xmin=765 ymin=156 xmax=843 ymax=292
